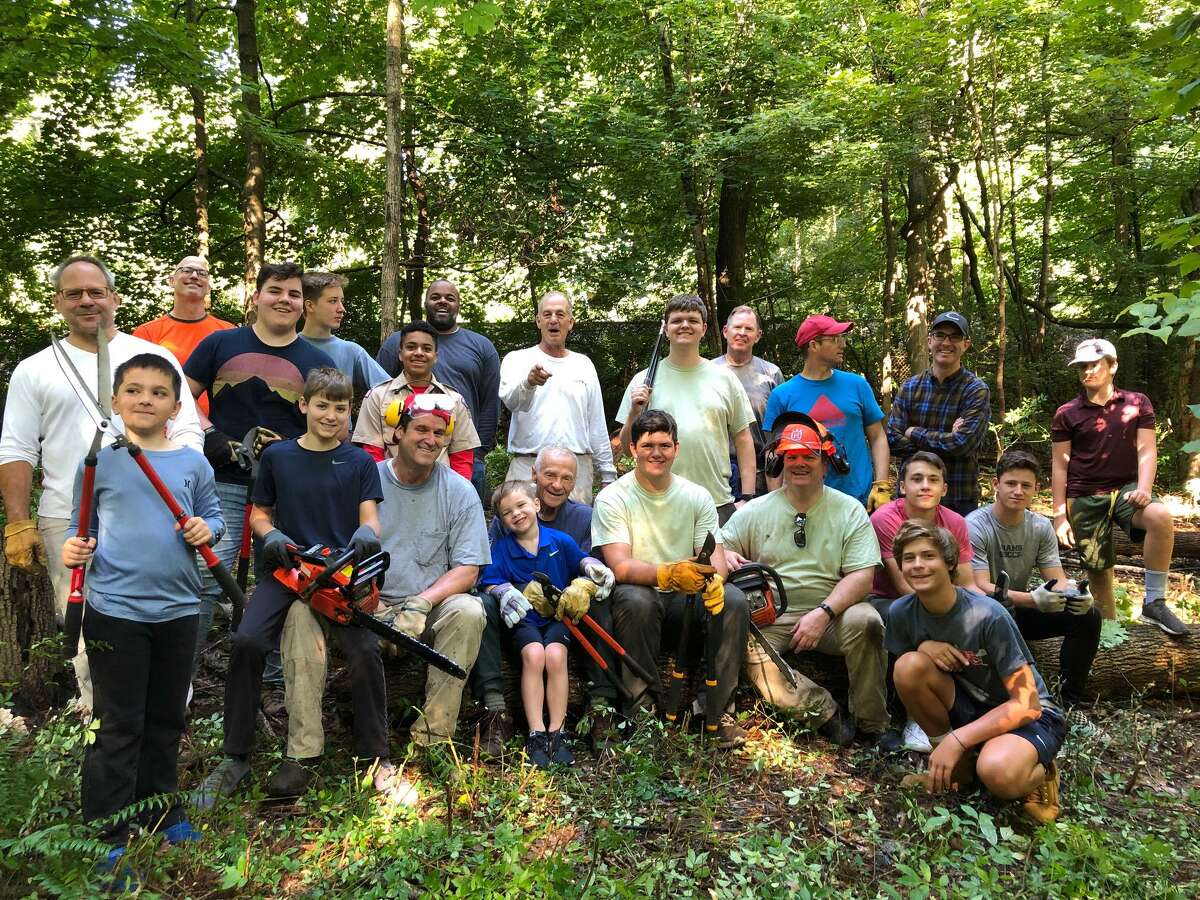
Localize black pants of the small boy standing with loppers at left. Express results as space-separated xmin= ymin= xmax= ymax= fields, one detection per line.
xmin=80 ymin=608 xmax=199 ymax=844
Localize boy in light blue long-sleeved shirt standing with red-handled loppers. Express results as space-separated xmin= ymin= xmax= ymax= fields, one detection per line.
xmin=62 ymin=353 xmax=224 ymax=870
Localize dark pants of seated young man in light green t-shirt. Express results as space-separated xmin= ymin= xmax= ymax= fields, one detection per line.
xmin=611 ymin=584 xmax=750 ymax=721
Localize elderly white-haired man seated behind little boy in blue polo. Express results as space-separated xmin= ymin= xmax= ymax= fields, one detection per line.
xmin=469 ymin=446 xmax=617 ymax=756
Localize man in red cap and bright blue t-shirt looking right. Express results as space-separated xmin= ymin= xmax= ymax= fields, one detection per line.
xmin=763 ymin=316 xmax=892 ymax=512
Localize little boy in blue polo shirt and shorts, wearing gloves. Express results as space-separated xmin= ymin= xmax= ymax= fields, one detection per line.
xmin=479 ymin=481 xmax=613 ymax=768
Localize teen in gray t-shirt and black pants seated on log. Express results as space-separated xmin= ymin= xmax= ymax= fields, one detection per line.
xmin=967 ymin=450 xmax=1100 ymax=709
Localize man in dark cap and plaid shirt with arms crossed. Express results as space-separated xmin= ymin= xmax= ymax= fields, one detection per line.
xmin=887 ymin=311 xmax=991 ymax=516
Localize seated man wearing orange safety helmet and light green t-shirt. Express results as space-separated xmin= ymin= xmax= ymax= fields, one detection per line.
xmin=721 ymin=413 xmax=900 ymax=751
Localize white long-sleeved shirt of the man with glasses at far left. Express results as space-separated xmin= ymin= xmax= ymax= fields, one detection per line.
xmin=0 ymin=331 xmax=204 ymax=518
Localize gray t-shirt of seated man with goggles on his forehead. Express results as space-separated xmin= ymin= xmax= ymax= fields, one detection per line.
xmin=379 ymin=460 xmax=492 ymax=604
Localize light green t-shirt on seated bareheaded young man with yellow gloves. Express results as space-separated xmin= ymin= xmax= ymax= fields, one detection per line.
xmin=592 ymin=472 xmax=721 ymax=565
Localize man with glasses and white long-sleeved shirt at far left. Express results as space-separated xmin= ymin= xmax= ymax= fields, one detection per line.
xmin=0 ymin=256 xmax=204 ymax=709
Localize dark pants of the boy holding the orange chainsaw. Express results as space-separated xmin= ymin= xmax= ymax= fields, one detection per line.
xmin=224 ymin=578 xmax=388 ymax=758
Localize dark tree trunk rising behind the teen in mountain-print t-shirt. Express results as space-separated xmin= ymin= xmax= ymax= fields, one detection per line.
xmin=234 ymin=0 xmax=266 ymax=307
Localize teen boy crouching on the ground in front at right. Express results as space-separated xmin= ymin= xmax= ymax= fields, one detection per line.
xmin=886 ymin=521 xmax=1067 ymax=822
